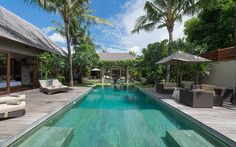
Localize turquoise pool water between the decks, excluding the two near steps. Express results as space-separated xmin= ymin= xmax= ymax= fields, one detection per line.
xmin=10 ymin=87 xmax=229 ymax=147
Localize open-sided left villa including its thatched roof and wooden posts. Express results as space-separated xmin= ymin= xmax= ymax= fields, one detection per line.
xmin=0 ymin=6 xmax=66 ymax=94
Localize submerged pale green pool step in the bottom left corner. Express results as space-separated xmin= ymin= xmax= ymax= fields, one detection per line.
xmin=19 ymin=127 xmax=73 ymax=147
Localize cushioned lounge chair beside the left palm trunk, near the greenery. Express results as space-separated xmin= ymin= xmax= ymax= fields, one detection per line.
xmin=39 ymin=79 xmax=69 ymax=95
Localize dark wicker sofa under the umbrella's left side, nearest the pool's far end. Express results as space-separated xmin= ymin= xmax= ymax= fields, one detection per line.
xmin=156 ymin=83 xmax=177 ymax=94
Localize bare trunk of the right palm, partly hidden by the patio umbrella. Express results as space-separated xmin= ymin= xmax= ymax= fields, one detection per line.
xmin=166 ymin=26 xmax=174 ymax=82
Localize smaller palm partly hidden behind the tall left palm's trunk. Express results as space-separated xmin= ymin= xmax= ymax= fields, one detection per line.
xmin=51 ymin=5 xmax=112 ymax=82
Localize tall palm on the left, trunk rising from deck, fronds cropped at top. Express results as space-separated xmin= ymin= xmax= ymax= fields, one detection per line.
xmin=25 ymin=0 xmax=89 ymax=86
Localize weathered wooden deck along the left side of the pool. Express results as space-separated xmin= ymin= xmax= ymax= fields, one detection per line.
xmin=0 ymin=87 xmax=90 ymax=146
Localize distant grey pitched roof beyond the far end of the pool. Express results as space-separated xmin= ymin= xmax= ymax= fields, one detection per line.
xmin=98 ymin=52 xmax=135 ymax=61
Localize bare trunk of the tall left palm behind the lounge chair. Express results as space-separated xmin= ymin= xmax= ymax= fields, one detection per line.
xmin=64 ymin=18 xmax=73 ymax=86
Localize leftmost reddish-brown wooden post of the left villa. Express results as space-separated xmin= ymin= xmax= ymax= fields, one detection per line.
xmin=6 ymin=53 xmax=11 ymax=94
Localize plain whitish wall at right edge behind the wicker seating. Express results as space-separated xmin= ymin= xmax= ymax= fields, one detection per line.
xmin=202 ymin=60 xmax=236 ymax=89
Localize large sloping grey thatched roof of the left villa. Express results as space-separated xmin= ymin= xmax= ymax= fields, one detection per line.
xmin=0 ymin=6 xmax=66 ymax=55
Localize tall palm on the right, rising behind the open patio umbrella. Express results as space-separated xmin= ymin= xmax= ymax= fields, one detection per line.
xmin=132 ymin=0 xmax=196 ymax=81
